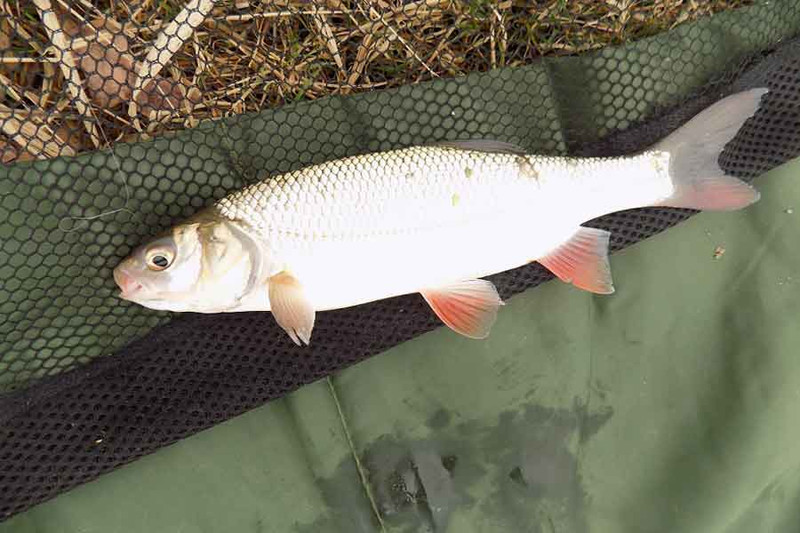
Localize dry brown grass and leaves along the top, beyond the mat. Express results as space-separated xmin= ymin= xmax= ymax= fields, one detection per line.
xmin=0 ymin=0 xmax=752 ymax=162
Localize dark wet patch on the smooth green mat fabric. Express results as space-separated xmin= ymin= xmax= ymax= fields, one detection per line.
xmin=297 ymin=399 xmax=613 ymax=533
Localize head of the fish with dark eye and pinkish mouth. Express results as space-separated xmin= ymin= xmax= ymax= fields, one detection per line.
xmin=114 ymin=213 xmax=259 ymax=313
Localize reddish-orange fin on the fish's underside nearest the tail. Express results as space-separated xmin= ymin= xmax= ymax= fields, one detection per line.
xmin=538 ymin=227 xmax=614 ymax=294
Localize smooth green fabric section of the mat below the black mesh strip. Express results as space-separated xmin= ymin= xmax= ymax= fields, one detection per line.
xmin=9 ymin=156 xmax=800 ymax=533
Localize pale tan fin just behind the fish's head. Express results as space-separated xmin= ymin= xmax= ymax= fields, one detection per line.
xmin=267 ymin=271 xmax=316 ymax=346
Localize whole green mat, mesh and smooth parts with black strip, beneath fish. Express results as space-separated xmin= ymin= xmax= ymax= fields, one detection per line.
xmin=0 ymin=2 xmax=800 ymax=531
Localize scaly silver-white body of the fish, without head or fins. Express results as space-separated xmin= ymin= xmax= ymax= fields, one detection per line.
xmin=221 ymin=147 xmax=671 ymax=310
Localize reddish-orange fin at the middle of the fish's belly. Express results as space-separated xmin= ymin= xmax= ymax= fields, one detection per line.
xmin=420 ymin=279 xmax=504 ymax=339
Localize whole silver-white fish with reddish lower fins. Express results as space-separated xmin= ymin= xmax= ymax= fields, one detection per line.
xmin=113 ymin=88 xmax=768 ymax=346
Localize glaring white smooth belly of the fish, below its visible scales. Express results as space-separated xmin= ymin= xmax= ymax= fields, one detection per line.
xmin=291 ymin=217 xmax=577 ymax=310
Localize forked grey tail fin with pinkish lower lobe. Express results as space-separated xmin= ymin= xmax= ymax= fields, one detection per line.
xmin=654 ymin=89 xmax=767 ymax=211
